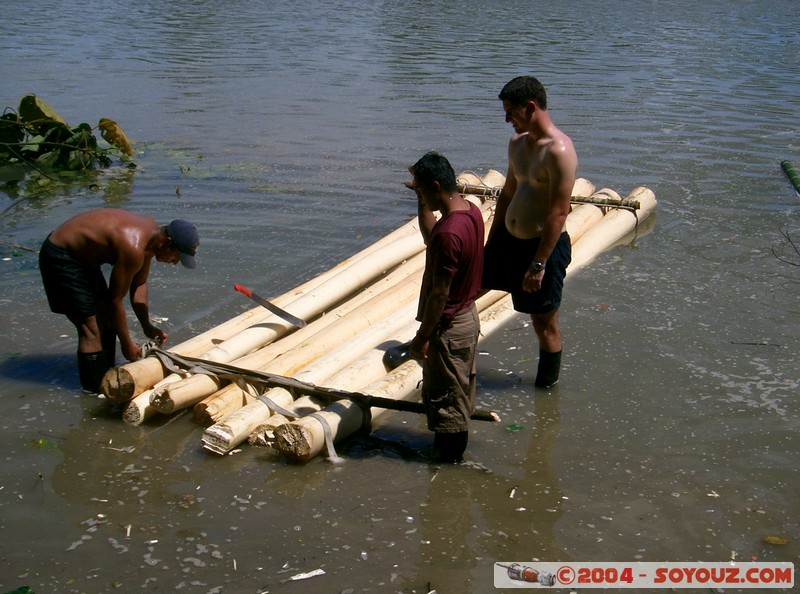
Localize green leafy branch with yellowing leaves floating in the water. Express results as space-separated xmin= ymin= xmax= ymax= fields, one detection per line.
xmin=0 ymin=95 xmax=133 ymax=173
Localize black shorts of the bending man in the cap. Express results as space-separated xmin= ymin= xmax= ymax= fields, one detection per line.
xmin=39 ymin=237 xmax=108 ymax=318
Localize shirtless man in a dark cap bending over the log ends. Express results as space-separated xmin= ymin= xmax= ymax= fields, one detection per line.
xmin=39 ymin=209 xmax=200 ymax=392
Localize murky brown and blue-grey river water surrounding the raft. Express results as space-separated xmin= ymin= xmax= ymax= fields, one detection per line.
xmin=0 ymin=0 xmax=800 ymax=593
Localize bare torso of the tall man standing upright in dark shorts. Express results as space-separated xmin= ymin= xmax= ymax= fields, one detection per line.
xmin=505 ymin=127 xmax=577 ymax=239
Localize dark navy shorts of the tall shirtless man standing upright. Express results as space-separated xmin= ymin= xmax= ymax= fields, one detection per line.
xmin=482 ymin=225 xmax=572 ymax=314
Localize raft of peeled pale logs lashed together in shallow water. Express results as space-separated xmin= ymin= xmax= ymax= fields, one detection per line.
xmin=102 ymin=170 xmax=656 ymax=462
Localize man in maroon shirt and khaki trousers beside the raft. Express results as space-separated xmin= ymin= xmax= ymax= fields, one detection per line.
xmin=409 ymin=152 xmax=484 ymax=462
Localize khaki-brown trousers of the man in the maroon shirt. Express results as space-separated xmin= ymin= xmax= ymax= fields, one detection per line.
xmin=422 ymin=304 xmax=480 ymax=433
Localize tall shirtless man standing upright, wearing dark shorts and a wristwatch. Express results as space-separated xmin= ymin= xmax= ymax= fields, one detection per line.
xmin=483 ymin=76 xmax=578 ymax=388
